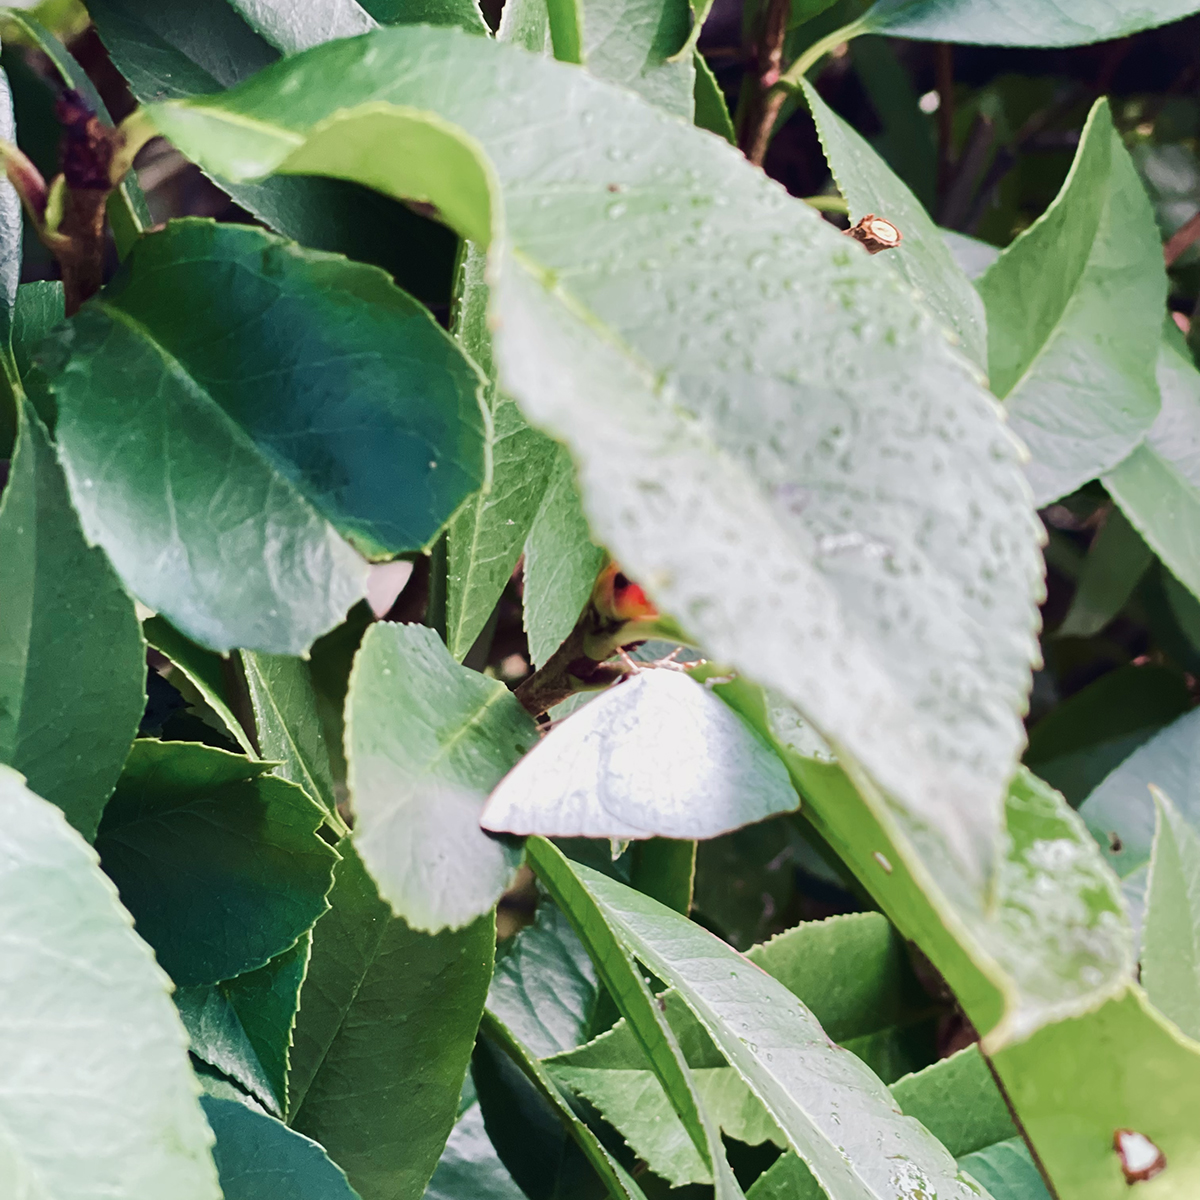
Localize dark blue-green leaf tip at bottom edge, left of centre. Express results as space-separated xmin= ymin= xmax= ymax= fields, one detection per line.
xmin=200 ymin=1096 xmax=360 ymax=1200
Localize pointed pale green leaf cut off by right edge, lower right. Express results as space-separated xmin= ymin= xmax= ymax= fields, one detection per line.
xmin=1141 ymin=788 xmax=1200 ymax=1040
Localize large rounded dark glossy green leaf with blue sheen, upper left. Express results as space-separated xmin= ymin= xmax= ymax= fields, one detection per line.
xmin=49 ymin=220 xmax=486 ymax=654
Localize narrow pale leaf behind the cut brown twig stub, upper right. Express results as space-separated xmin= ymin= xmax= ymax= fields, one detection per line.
xmin=802 ymin=79 xmax=988 ymax=364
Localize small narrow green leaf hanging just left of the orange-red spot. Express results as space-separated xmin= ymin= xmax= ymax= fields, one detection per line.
xmin=522 ymin=446 xmax=606 ymax=666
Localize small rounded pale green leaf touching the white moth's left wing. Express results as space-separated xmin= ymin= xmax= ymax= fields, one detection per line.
xmin=346 ymin=623 xmax=536 ymax=931
